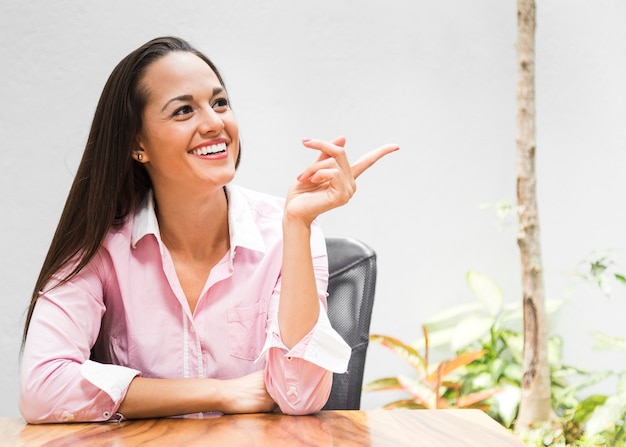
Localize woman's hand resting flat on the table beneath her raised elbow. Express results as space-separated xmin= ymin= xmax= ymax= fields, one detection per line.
xmin=220 ymin=370 xmax=276 ymax=413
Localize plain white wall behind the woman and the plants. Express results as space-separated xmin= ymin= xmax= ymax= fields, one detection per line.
xmin=0 ymin=0 xmax=626 ymax=415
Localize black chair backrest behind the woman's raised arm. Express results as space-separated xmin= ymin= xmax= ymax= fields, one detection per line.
xmin=323 ymin=238 xmax=376 ymax=410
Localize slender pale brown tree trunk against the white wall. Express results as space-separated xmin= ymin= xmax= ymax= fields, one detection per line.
xmin=515 ymin=0 xmax=552 ymax=433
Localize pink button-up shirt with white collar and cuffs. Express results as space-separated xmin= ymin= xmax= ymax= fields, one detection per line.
xmin=20 ymin=186 xmax=350 ymax=423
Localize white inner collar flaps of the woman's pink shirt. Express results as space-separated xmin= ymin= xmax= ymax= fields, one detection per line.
xmin=131 ymin=185 xmax=266 ymax=259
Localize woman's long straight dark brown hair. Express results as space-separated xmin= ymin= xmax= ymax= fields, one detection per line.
xmin=22 ymin=37 xmax=232 ymax=347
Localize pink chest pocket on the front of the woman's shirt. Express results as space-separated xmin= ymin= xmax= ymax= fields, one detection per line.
xmin=228 ymin=303 xmax=267 ymax=360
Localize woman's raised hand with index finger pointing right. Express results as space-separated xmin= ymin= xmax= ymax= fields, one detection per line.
xmin=285 ymin=137 xmax=399 ymax=224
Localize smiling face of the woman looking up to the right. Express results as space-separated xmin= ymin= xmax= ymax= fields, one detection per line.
xmin=133 ymin=51 xmax=239 ymax=193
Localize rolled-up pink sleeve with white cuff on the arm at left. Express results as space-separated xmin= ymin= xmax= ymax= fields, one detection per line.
xmin=19 ymin=257 xmax=139 ymax=423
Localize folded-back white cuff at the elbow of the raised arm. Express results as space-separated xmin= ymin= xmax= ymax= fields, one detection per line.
xmin=256 ymin=302 xmax=352 ymax=374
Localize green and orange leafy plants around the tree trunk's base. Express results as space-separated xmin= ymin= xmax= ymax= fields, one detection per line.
xmin=364 ymin=272 xmax=626 ymax=447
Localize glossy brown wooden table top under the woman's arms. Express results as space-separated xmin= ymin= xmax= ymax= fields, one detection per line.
xmin=0 ymin=410 xmax=524 ymax=447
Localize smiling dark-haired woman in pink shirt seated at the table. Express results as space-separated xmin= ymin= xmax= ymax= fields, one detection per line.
xmin=20 ymin=37 xmax=397 ymax=423
